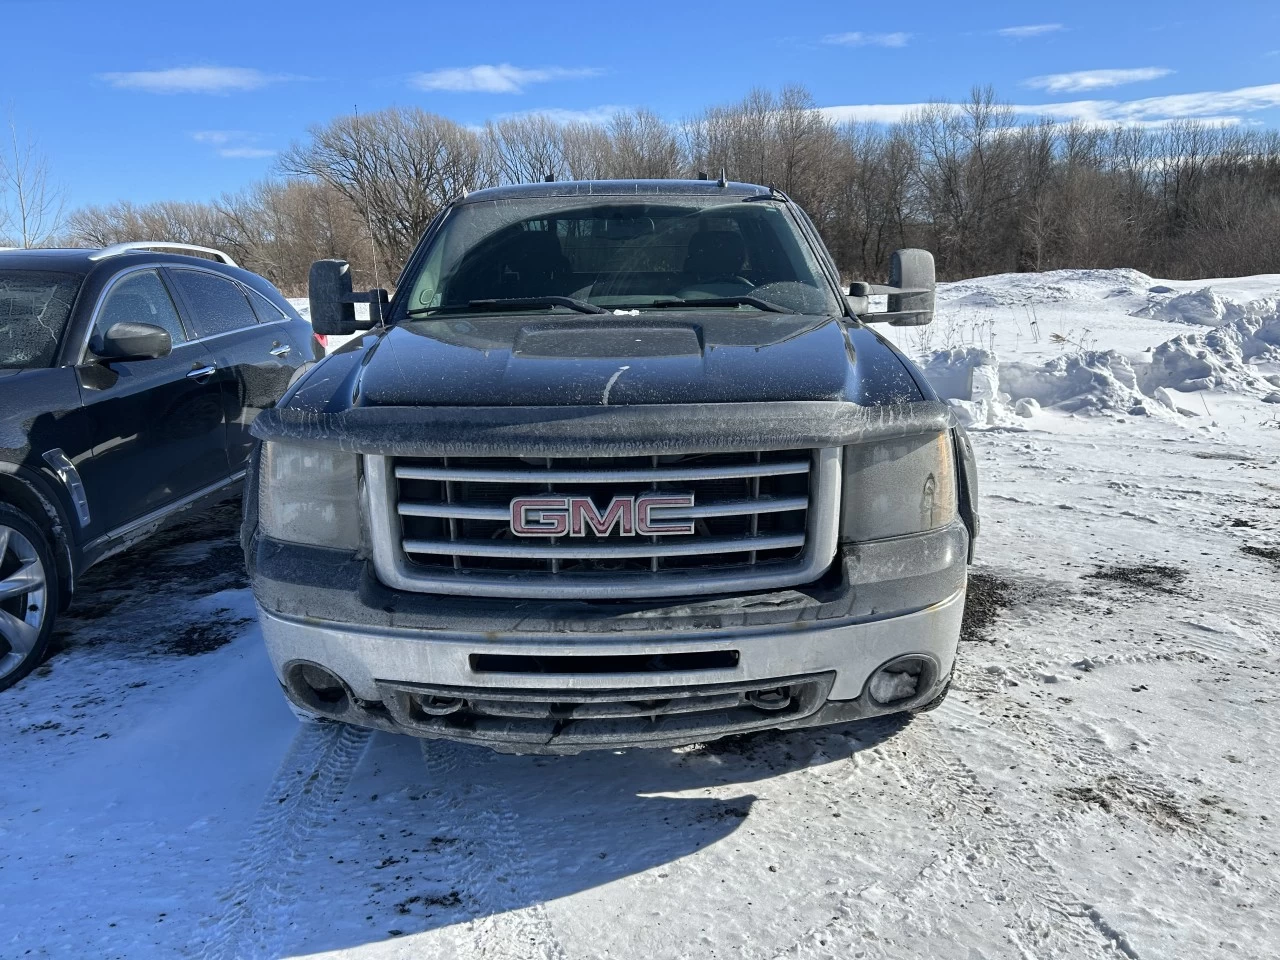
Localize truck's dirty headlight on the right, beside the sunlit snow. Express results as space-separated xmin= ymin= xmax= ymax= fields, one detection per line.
xmin=840 ymin=434 xmax=957 ymax=543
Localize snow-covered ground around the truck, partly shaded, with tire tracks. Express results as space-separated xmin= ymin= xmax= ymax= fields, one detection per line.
xmin=0 ymin=271 xmax=1280 ymax=960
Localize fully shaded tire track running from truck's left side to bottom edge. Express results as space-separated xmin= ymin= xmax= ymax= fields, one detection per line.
xmin=201 ymin=722 xmax=372 ymax=960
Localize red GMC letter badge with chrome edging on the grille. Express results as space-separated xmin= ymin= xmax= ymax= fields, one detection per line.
xmin=511 ymin=493 xmax=694 ymax=536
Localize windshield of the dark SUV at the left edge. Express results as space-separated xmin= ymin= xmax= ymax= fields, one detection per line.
xmin=0 ymin=270 xmax=82 ymax=370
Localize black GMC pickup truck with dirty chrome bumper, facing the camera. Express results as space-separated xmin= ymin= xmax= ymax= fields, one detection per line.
xmin=244 ymin=180 xmax=978 ymax=753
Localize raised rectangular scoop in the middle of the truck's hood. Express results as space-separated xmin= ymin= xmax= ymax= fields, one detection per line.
xmin=511 ymin=323 xmax=703 ymax=360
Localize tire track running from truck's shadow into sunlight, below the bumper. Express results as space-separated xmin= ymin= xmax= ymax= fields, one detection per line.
xmin=421 ymin=740 xmax=567 ymax=960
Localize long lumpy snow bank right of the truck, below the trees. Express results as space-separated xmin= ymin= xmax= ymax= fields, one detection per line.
xmin=922 ymin=277 xmax=1280 ymax=428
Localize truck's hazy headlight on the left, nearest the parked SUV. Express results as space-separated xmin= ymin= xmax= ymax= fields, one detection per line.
xmin=257 ymin=443 xmax=360 ymax=550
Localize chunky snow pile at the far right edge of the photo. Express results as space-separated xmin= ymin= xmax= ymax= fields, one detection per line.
xmin=1143 ymin=312 xmax=1280 ymax=393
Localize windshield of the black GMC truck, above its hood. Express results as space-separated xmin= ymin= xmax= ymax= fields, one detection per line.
xmin=406 ymin=197 xmax=841 ymax=316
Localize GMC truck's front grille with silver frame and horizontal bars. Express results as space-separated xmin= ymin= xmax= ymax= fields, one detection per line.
xmin=365 ymin=449 xmax=840 ymax=599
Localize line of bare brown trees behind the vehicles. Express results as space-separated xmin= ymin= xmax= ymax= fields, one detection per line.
xmin=52 ymin=86 xmax=1280 ymax=294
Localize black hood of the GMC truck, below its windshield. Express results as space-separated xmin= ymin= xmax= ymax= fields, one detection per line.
xmin=313 ymin=311 xmax=922 ymax=412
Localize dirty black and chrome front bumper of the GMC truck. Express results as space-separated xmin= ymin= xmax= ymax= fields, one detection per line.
xmin=253 ymin=524 xmax=968 ymax=753
